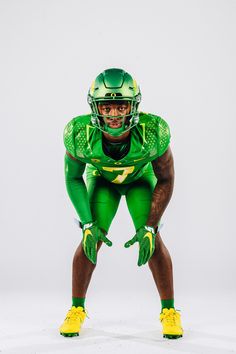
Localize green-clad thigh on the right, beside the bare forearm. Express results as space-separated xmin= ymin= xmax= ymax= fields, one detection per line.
xmin=126 ymin=172 xmax=157 ymax=230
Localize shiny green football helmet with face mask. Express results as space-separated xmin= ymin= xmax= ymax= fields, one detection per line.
xmin=88 ymin=68 xmax=141 ymax=136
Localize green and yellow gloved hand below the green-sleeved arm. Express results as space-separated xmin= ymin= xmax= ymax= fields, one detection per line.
xmin=82 ymin=222 xmax=112 ymax=264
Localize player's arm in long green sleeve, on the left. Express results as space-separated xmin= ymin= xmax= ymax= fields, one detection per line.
xmin=65 ymin=155 xmax=92 ymax=223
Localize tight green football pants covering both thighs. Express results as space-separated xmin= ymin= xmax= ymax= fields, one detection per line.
xmin=87 ymin=164 xmax=157 ymax=232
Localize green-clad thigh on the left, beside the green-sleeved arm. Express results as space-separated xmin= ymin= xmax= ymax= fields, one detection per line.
xmin=87 ymin=169 xmax=121 ymax=232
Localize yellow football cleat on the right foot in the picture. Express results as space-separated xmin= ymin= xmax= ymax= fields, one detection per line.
xmin=160 ymin=308 xmax=183 ymax=339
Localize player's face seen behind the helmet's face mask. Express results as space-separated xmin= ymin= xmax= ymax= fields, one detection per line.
xmin=98 ymin=102 xmax=130 ymax=129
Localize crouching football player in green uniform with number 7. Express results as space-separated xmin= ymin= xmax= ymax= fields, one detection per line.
xmin=60 ymin=68 xmax=183 ymax=339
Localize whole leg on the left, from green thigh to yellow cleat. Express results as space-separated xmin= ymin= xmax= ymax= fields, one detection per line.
xmin=59 ymin=173 xmax=121 ymax=337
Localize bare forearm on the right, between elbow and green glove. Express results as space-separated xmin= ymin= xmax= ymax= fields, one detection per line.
xmin=146 ymin=178 xmax=174 ymax=227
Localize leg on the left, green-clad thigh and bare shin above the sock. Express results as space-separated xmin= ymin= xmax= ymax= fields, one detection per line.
xmin=72 ymin=174 xmax=121 ymax=298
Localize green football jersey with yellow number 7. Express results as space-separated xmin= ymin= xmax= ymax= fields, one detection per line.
xmin=64 ymin=112 xmax=170 ymax=184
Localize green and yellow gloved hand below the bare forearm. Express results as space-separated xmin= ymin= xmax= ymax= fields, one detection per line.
xmin=124 ymin=225 xmax=156 ymax=266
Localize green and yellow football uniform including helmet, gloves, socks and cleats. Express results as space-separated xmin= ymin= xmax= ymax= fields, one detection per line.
xmin=60 ymin=68 xmax=183 ymax=338
